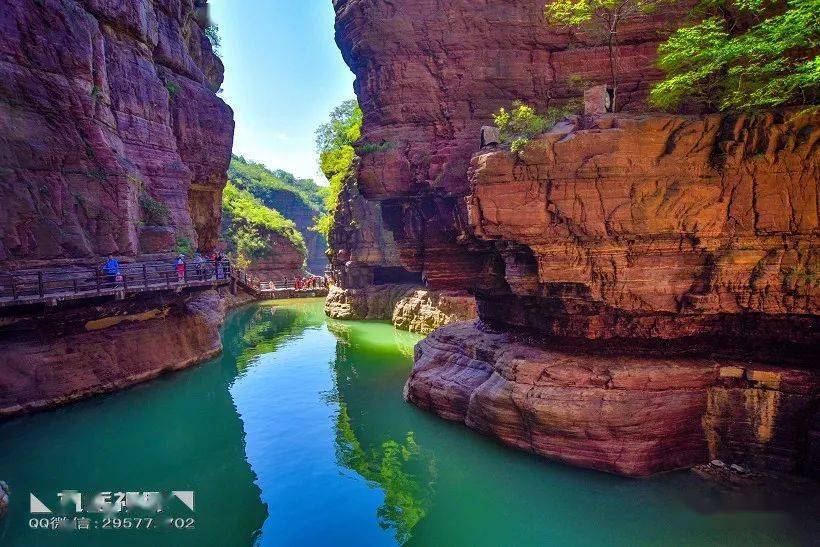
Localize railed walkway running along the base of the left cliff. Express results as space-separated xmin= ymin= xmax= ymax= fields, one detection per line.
xmin=0 ymin=260 xmax=231 ymax=307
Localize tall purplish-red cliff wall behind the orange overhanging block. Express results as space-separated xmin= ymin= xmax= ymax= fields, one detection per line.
xmin=334 ymin=0 xmax=686 ymax=289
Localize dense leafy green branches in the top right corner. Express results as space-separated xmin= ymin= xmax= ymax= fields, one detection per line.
xmin=650 ymin=0 xmax=820 ymax=110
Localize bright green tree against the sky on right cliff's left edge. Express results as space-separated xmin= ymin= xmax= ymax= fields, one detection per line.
xmin=316 ymin=99 xmax=362 ymax=238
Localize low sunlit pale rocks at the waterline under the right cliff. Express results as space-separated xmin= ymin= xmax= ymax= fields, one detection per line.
xmin=325 ymin=284 xmax=478 ymax=334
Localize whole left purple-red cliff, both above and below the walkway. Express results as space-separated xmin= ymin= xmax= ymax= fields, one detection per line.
xmin=0 ymin=0 xmax=233 ymax=416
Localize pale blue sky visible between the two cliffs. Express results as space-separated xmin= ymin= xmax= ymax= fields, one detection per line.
xmin=208 ymin=0 xmax=354 ymax=184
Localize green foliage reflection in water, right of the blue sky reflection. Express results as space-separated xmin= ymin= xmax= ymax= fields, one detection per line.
xmin=328 ymin=321 xmax=436 ymax=543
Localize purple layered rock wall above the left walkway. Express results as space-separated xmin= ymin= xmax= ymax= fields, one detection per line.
xmin=0 ymin=0 xmax=233 ymax=268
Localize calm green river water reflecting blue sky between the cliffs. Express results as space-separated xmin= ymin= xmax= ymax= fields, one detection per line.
xmin=0 ymin=300 xmax=820 ymax=547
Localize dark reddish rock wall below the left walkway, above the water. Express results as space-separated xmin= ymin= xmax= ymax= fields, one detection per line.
xmin=0 ymin=291 xmax=225 ymax=417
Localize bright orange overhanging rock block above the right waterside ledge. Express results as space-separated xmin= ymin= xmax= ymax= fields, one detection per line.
xmin=468 ymin=114 xmax=820 ymax=353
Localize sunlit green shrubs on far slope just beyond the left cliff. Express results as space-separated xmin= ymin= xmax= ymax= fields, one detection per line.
xmin=222 ymin=182 xmax=307 ymax=266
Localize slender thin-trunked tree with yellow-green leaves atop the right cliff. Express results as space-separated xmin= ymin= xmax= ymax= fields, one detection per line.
xmin=544 ymin=0 xmax=670 ymax=112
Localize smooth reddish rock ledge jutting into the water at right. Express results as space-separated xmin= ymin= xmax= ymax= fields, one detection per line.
xmin=404 ymin=322 xmax=820 ymax=476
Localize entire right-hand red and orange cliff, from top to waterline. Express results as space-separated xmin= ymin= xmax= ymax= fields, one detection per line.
xmin=330 ymin=0 xmax=820 ymax=476
